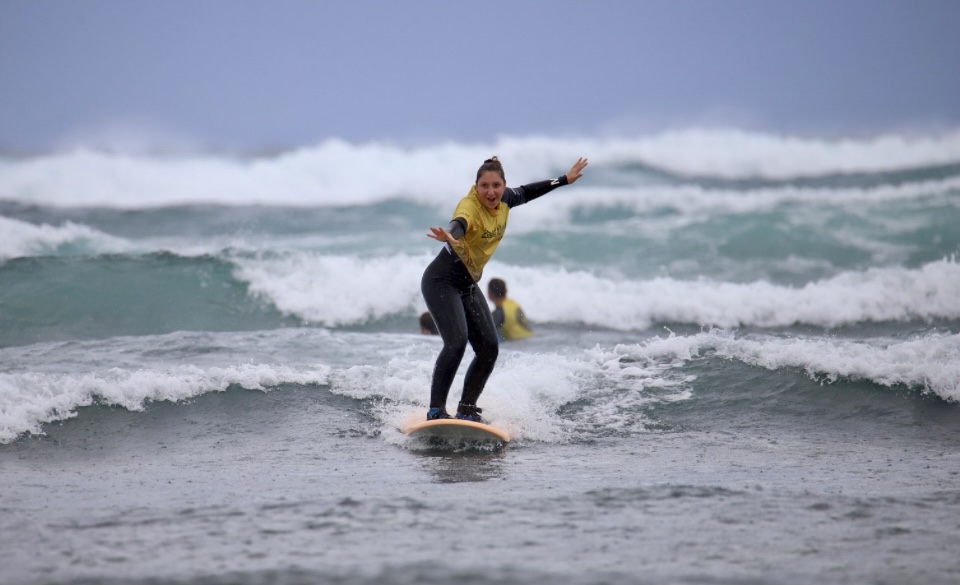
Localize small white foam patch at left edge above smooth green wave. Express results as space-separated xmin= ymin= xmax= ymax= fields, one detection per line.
xmin=0 ymin=217 xmax=131 ymax=259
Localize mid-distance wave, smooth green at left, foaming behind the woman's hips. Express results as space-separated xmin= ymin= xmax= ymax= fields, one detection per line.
xmin=0 ymin=251 xmax=960 ymax=345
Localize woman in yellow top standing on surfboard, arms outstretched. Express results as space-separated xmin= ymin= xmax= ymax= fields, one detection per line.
xmin=420 ymin=157 xmax=587 ymax=422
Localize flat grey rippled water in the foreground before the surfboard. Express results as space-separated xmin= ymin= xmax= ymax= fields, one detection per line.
xmin=0 ymin=372 xmax=960 ymax=584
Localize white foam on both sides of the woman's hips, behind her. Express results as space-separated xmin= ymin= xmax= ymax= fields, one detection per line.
xmin=234 ymin=252 xmax=960 ymax=330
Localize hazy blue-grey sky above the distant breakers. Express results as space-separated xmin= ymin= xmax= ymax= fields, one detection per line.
xmin=0 ymin=0 xmax=960 ymax=150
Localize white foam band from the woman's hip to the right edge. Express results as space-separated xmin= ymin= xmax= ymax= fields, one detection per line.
xmin=485 ymin=254 xmax=960 ymax=330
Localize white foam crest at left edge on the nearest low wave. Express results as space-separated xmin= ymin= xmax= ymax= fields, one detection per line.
xmin=0 ymin=363 xmax=330 ymax=443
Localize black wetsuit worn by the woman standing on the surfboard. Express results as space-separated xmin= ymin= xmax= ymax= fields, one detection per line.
xmin=420 ymin=175 xmax=567 ymax=408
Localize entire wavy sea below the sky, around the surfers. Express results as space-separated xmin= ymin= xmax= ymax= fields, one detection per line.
xmin=0 ymin=130 xmax=960 ymax=585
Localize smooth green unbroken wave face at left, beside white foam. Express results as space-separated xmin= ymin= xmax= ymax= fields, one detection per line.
xmin=0 ymin=253 xmax=287 ymax=347
